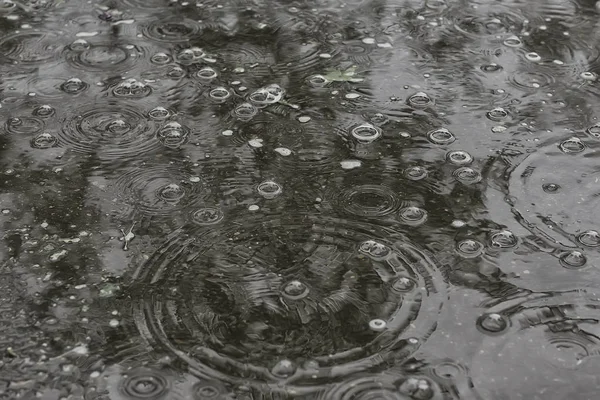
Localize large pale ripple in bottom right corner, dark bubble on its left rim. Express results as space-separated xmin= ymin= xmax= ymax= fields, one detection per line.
xmin=470 ymin=290 xmax=600 ymax=399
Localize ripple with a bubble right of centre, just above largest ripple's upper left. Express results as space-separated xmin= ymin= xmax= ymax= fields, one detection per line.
xmin=115 ymin=165 xmax=206 ymax=217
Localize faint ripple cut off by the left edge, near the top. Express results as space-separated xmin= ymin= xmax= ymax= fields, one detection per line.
xmin=0 ymin=32 xmax=61 ymax=64
